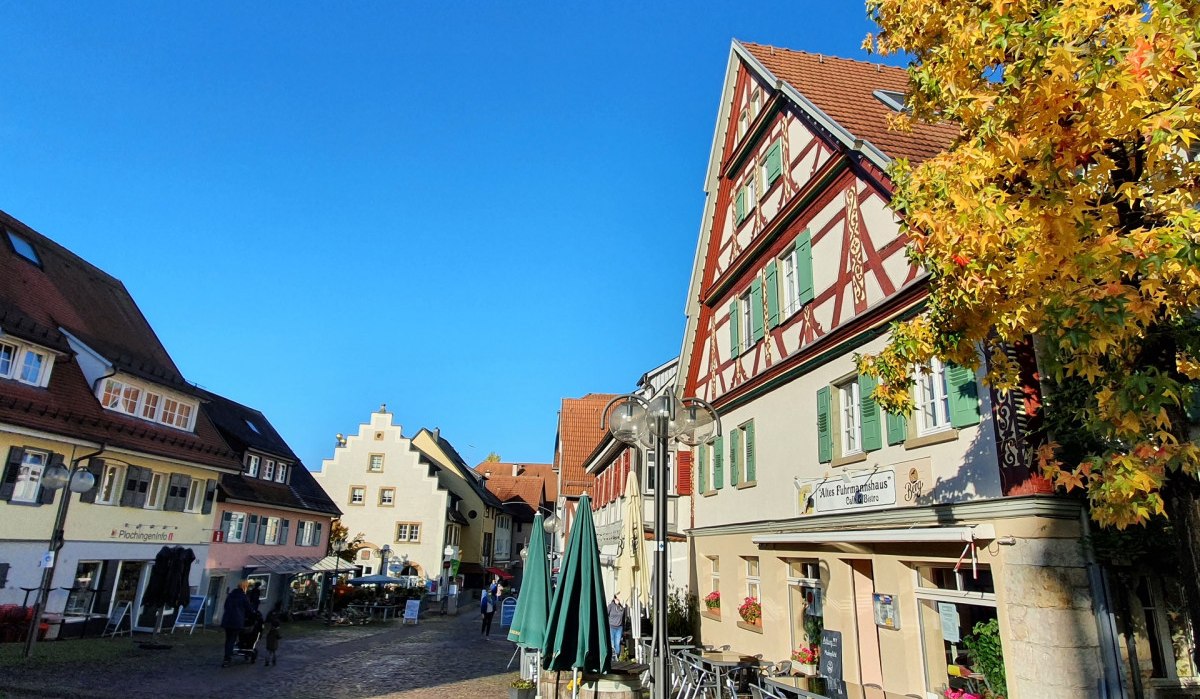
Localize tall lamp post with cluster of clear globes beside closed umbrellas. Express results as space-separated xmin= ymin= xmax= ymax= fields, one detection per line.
xmin=601 ymin=389 xmax=721 ymax=699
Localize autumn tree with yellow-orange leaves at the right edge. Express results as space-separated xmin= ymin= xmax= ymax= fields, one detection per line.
xmin=860 ymin=0 xmax=1200 ymax=646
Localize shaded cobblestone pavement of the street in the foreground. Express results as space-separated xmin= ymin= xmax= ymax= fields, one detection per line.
xmin=0 ymin=613 xmax=517 ymax=699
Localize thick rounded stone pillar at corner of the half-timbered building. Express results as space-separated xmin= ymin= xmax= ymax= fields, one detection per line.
xmin=996 ymin=538 xmax=1103 ymax=699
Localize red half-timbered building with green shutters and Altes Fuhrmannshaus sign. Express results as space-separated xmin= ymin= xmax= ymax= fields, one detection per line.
xmin=678 ymin=42 xmax=1111 ymax=699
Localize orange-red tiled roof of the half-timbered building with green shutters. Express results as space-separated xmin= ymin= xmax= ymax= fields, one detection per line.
xmin=742 ymin=43 xmax=959 ymax=163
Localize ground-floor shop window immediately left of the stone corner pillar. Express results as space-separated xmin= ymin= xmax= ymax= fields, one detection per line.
xmin=916 ymin=566 xmax=1000 ymax=693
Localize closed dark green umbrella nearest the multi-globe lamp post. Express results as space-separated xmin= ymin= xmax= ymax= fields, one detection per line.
xmin=541 ymin=495 xmax=612 ymax=689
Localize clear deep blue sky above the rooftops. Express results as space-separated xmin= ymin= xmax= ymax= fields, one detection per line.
xmin=0 ymin=0 xmax=897 ymax=468
